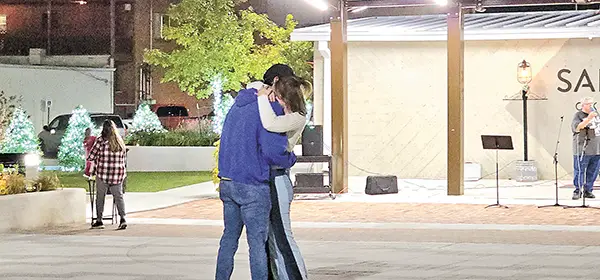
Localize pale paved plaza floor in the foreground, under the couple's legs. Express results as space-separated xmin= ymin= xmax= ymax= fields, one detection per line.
xmin=0 ymin=221 xmax=600 ymax=280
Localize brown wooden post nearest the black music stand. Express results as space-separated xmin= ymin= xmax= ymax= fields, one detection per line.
xmin=447 ymin=4 xmax=465 ymax=195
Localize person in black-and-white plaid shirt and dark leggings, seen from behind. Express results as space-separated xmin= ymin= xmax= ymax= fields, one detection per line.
xmin=87 ymin=120 xmax=127 ymax=229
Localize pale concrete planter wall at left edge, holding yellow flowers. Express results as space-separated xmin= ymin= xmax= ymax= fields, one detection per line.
xmin=0 ymin=188 xmax=87 ymax=233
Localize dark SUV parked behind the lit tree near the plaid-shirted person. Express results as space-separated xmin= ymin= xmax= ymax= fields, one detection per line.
xmin=38 ymin=113 xmax=127 ymax=158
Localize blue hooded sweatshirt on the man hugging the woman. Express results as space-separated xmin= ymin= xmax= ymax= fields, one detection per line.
xmin=219 ymin=89 xmax=296 ymax=185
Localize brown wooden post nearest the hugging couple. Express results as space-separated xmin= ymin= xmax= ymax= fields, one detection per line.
xmin=329 ymin=1 xmax=348 ymax=193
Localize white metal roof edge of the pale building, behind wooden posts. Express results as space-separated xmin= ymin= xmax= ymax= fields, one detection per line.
xmin=291 ymin=10 xmax=600 ymax=41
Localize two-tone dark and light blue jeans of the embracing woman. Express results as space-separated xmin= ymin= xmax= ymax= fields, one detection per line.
xmin=268 ymin=170 xmax=308 ymax=280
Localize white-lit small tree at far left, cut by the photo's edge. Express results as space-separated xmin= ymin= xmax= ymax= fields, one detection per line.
xmin=2 ymin=108 xmax=40 ymax=153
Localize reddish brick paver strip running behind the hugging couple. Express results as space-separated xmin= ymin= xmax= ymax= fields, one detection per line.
xmin=128 ymin=199 xmax=600 ymax=225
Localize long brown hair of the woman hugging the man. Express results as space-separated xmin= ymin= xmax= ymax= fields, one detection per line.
xmin=274 ymin=76 xmax=312 ymax=116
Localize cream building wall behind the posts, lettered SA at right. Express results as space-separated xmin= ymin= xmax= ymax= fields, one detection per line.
xmin=315 ymin=39 xmax=600 ymax=179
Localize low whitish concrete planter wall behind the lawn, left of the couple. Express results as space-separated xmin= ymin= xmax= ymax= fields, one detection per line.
xmin=127 ymin=146 xmax=216 ymax=172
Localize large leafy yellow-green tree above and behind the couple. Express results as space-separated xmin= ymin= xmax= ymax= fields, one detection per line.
xmin=145 ymin=0 xmax=313 ymax=98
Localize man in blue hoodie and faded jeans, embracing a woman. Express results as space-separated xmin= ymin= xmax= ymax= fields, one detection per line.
xmin=216 ymin=70 xmax=296 ymax=280
